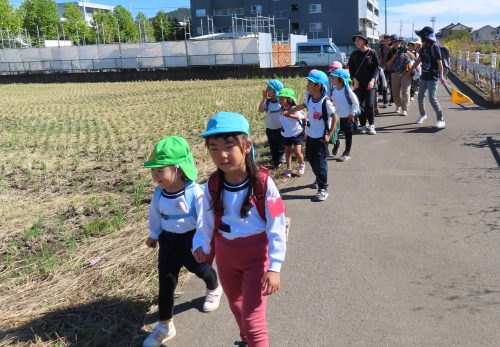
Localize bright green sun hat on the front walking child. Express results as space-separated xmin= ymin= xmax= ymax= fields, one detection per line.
xmin=144 ymin=136 xmax=198 ymax=181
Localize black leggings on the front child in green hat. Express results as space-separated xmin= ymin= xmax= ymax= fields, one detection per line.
xmin=158 ymin=230 xmax=218 ymax=320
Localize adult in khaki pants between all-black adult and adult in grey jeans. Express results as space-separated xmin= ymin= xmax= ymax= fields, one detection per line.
xmin=387 ymin=35 xmax=415 ymax=116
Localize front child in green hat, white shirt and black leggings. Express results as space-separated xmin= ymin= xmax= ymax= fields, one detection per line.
xmin=143 ymin=136 xmax=222 ymax=347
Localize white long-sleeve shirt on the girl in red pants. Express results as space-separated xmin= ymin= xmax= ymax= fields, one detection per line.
xmin=193 ymin=177 xmax=286 ymax=272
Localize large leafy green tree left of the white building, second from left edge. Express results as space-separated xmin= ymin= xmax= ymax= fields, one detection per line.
xmin=20 ymin=0 xmax=59 ymax=44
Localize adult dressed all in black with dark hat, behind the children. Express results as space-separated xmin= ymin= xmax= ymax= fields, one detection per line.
xmin=347 ymin=34 xmax=379 ymax=135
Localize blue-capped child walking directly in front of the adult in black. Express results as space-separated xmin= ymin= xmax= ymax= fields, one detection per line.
xmin=331 ymin=69 xmax=359 ymax=161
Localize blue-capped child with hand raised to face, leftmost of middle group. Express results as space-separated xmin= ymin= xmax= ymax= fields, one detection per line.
xmin=258 ymin=79 xmax=285 ymax=169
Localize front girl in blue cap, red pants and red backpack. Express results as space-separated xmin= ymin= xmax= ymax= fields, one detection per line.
xmin=193 ymin=112 xmax=286 ymax=347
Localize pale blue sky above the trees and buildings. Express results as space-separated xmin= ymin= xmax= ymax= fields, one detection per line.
xmin=11 ymin=0 xmax=500 ymax=37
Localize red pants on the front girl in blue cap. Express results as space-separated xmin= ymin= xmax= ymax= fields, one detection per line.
xmin=215 ymin=232 xmax=269 ymax=347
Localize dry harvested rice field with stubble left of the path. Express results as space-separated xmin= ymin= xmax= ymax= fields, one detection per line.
xmin=0 ymin=77 xmax=305 ymax=346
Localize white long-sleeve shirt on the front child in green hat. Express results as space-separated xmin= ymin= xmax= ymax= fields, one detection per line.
xmin=148 ymin=184 xmax=204 ymax=240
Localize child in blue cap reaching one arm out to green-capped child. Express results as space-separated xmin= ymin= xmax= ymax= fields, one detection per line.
xmin=284 ymin=70 xmax=337 ymax=201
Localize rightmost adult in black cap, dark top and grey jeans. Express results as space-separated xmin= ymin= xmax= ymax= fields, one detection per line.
xmin=411 ymin=27 xmax=446 ymax=129
